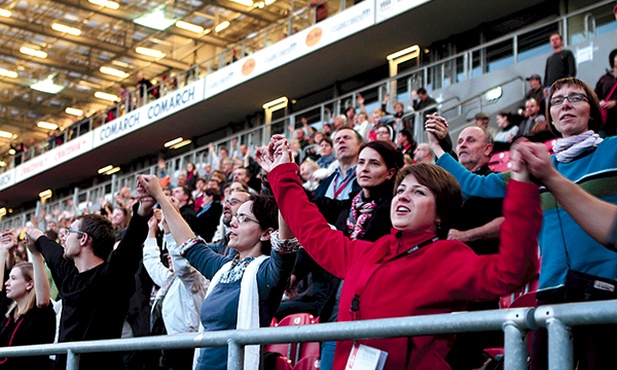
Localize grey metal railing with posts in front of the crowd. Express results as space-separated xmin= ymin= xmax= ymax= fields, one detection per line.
xmin=0 ymin=300 xmax=617 ymax=370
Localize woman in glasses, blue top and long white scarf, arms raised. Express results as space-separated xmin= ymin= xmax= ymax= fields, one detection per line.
xmin=138 ymin=176 xmax=298 ymax=370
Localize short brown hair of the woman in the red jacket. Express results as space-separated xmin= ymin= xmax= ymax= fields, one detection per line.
xmin=394 ymin=163 xmax=463 ymax=238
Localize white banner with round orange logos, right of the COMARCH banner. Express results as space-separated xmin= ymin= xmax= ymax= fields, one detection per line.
xmin=205 ymin=0 xmax=372 ymax=98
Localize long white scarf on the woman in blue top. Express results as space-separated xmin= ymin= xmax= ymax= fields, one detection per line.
xmin=206 ymin=255 xmax=270 ymax=370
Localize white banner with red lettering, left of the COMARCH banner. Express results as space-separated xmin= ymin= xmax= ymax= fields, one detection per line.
xmin=15 ymin=131 xmax=93 ymax=183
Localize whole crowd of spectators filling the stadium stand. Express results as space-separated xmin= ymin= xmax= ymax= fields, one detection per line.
xmin=0 ymin=35 xmax=617 ymax=370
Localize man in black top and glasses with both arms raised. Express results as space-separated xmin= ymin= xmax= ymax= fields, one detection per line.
xmin=27 ymin=183 xmax=155 ymax=369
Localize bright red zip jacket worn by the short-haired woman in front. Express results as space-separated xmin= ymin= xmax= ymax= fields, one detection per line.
xmin=268 ymin=164 xmax=542 ymax=370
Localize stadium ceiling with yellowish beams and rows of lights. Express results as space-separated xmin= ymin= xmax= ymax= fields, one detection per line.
xmin=0 ymin=0 xmax=300 ymax=154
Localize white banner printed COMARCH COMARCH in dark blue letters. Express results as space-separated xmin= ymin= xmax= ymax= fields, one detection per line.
xmin=94 ymin=79 xmax=205 ymax=148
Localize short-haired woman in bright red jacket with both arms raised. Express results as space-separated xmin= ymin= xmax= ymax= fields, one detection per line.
xmin=256 ymin=135 xmax=541 ymax=370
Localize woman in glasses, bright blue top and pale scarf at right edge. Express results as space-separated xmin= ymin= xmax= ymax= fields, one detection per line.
xmin=426 ymin=77 xmax=617 ymax=369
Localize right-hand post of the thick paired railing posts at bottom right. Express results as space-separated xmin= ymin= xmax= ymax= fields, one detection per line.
xmin=546 ymin=317 xmax=574 ymax=370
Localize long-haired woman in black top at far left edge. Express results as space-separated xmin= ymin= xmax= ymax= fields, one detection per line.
xmin=0 ymin=230 xmax=56 ymax=369
